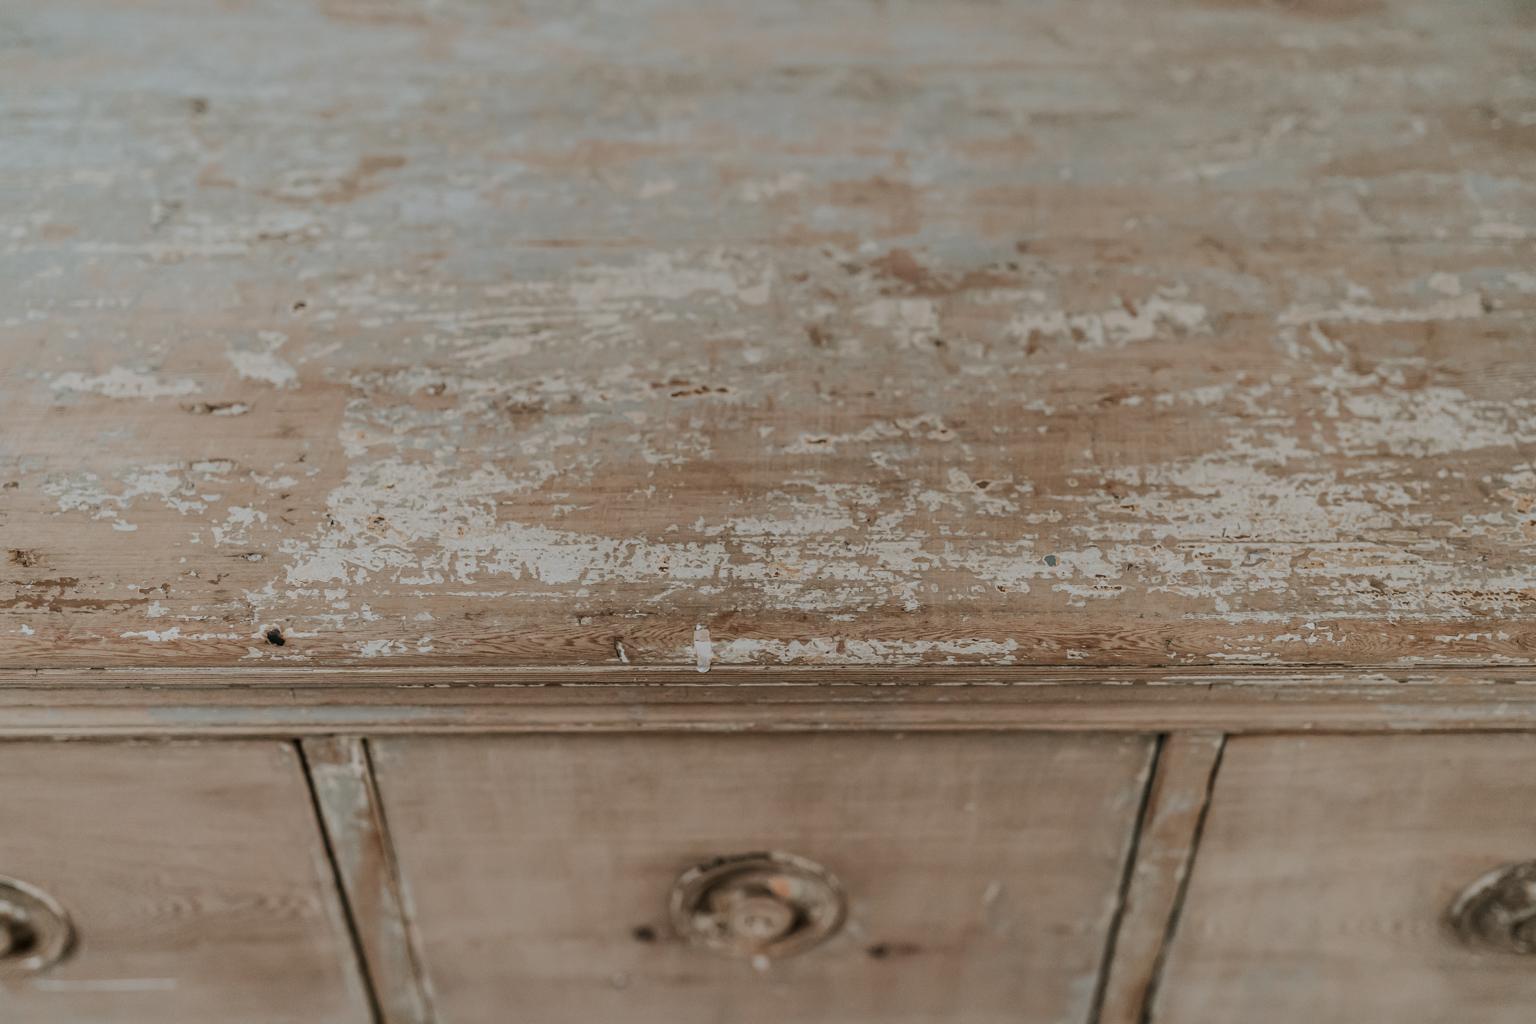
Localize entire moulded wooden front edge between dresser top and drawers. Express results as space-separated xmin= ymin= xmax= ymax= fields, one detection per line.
xmin=0 ymin=666 xmax=1536 ymax=737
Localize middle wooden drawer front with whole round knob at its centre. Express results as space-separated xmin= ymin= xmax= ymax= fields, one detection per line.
xmin=375 ymin=734 xmax=1150 ymax=1024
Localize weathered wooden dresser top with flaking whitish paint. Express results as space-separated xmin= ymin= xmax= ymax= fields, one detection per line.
xmin=0 ymin=0 xmax=1536 ymax=668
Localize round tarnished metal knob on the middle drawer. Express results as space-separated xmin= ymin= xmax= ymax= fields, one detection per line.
xmin=670 ymin=854 xmax=843 ymax=960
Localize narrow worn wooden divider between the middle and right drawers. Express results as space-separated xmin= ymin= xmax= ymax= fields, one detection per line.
xmin=1092 ymin=732 xmax=1226 ymax=1024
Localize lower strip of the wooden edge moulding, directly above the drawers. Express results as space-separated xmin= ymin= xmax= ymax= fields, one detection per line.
xmin=9 ymin=682 xmax=1536 ymax=737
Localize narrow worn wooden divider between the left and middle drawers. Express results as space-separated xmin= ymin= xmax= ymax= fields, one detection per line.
xmin=300 ymin=735 xmax=435 ymax=1024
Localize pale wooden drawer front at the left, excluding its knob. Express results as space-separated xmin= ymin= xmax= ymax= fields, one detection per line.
xmin=0 ymin=742 xmax=369 ymax=1024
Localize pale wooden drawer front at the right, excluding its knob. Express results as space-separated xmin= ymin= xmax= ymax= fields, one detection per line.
xmin=1154 ymin=734 xmax=1536 ymax=1024
